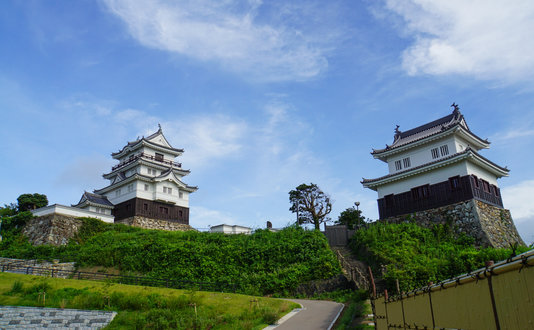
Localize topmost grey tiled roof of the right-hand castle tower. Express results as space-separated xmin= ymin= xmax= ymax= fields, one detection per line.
xmin=371 ymin=107 xmax=488 ymax=155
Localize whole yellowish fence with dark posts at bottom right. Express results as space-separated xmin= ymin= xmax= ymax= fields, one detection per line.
xmin=372 ymin=250 xmax=534 ymax=330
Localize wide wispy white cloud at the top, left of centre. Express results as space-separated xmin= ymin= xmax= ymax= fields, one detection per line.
xmin=103 ymin=0 xmax=336 ymax=81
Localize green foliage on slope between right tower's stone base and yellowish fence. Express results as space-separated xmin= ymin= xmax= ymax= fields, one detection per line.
xmin=351 ymin=223 xmax=526 ymax=292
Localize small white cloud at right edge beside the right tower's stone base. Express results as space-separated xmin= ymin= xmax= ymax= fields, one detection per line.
xmin=502 ymin=180 xmax=534 ymax=223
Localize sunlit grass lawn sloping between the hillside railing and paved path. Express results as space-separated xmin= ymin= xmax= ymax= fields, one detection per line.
xmin=0 ymin=273 xmax=299 ymax=329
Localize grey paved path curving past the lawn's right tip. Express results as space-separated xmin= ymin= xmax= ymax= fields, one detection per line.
xmin=270 ymin=299 xmax=343 ymax=330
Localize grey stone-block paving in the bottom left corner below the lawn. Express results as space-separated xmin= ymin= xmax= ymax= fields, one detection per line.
xmin=0 ymin=306 xmax=117 ymax=329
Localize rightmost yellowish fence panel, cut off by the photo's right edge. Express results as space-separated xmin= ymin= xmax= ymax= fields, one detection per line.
xmin=492 ymin=267 xmax=534 ymax=329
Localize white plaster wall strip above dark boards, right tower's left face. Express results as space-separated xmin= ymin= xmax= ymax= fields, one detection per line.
xmin=377 ymin=161 xmax=468 ymax=198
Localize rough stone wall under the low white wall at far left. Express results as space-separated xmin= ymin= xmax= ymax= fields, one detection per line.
xmin=22 ymin=214 xmax=82 ymax=245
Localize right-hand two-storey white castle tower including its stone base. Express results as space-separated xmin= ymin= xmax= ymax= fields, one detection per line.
xmin=362 ymin=104 xmax=523 ymax=247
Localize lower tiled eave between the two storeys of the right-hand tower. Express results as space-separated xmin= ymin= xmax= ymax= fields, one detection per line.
xmin=361 ymin=148 xmax=509 ymax=191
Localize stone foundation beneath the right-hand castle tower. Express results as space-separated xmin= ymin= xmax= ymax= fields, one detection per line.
xmin=383 ymin=199 xmax=525 ymax=248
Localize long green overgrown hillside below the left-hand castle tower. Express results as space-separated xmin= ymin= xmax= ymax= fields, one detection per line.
xmin=0 ymin=212 xmax=340 ymax=295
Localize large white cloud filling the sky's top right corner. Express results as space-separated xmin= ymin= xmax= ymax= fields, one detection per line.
xmin=386 ymin=0 xmax=534 ymax=82
